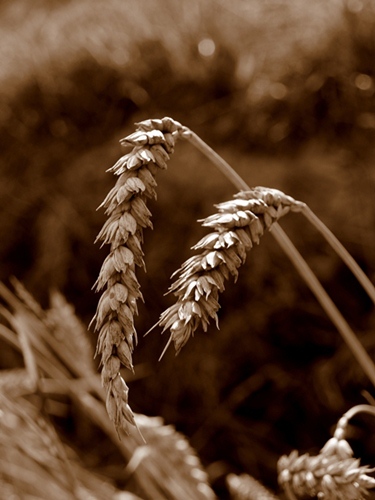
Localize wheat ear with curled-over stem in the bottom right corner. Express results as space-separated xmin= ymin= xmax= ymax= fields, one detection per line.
xmin=278 ymin=405 xmax=375 ymax=500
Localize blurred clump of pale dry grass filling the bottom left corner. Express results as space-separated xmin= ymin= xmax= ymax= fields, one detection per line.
xmin=0 ymin=395 xmax=137 ymax=500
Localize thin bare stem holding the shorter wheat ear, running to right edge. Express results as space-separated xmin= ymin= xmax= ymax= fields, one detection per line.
xmin=302 ymin=205 xmax=375 ymax=304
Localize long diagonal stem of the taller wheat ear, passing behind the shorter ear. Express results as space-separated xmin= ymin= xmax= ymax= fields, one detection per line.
xmin=182 ymin=129 xmax=375 ymax=386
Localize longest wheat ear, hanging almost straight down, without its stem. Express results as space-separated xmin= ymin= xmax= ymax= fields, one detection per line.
xmin=93 ymin=118 xmax=183 ymax=432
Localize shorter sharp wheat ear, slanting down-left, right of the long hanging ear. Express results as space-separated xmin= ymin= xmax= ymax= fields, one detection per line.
xmin=158 ymin=187 xmax=304 ymax=356
